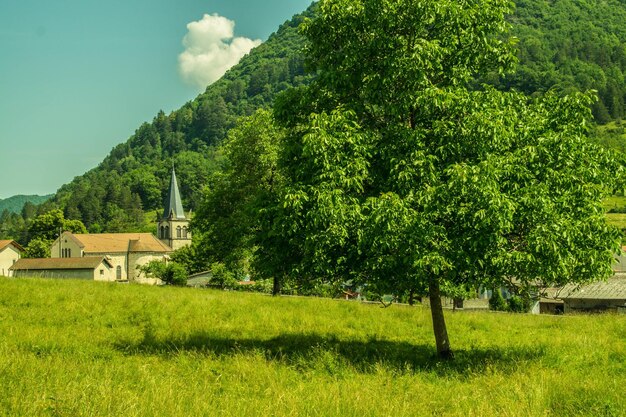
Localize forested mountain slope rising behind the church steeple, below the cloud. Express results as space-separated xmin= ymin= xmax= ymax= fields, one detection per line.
xmin=50 ymin=6 xmax=308 ymax=232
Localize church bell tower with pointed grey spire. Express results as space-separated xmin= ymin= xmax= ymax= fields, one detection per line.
xmin=157 ymin=167 xmax=191 ymax=250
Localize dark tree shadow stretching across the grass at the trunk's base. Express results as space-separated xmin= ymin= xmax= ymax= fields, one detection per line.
xmin=115 ymin=332 xmax=545 ymax=376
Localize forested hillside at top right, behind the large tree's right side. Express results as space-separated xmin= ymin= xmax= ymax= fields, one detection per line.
xmin=499 ymin=0 xmax=626 ymax=123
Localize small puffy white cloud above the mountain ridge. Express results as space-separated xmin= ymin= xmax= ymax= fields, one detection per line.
xmin=178 ymin=14 xmax=261 ymax=88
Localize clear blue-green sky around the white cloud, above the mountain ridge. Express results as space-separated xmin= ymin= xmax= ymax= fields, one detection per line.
xmin=0 ymin=0 xmax=311 ymax=198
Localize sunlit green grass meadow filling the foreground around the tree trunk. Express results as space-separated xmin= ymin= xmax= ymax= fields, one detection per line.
xmin=0 ymin=278 xmax=626 ymax=416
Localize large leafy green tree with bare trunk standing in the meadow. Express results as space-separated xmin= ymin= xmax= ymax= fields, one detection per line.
xmin=271 ymin=0 xmax=619 ymax=358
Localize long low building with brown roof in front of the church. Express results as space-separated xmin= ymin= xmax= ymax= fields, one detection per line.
xmin=11 ymin=256 xmax=115 ymax=281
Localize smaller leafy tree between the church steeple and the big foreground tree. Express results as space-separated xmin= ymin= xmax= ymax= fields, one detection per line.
xmin=192 ymin=110 xmax=284 ymax=294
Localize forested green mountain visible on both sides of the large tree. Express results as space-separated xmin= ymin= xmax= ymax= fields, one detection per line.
xmin=0 ymin=0 xmax=626 ymax=244
